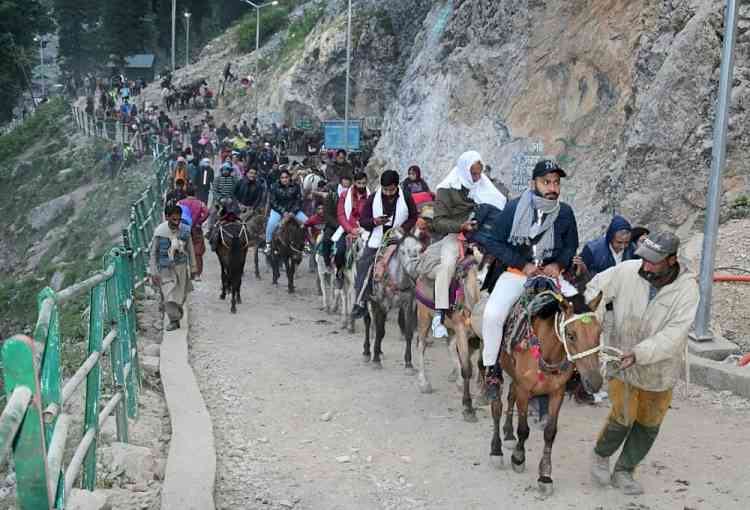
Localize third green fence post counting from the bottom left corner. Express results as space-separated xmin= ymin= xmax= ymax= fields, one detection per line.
xmin=83 ymin=282 xmax=106 ymax=491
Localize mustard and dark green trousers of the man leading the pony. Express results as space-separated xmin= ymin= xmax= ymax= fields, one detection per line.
xmin=594 ymin=379 xmax=672 ymax=473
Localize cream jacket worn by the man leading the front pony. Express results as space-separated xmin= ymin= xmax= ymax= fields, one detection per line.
xmin=586 ymin=260 xmax=698 ymax=391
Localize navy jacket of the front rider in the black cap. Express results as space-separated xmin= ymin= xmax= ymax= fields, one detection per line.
xmin=485 ymin=198 xmax=578 ymax=270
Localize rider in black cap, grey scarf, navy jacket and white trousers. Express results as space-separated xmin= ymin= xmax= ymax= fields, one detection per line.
xmin=482 ymin=160 xmax=578 ymax=400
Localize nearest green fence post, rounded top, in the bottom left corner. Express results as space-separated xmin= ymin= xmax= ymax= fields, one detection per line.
xmin=2 ymin=335 xmax=52 ymax=510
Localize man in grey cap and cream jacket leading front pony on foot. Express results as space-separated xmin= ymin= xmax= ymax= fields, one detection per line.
xmin=586 ymin=232 xmax=698 ymax=495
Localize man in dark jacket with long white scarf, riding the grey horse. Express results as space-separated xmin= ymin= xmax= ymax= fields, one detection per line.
xmin=352 ymin=170 xmax=418 ymax=319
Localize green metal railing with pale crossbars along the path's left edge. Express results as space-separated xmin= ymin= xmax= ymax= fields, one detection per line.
xmin=0 ymin=145 xmax=169 ymax=510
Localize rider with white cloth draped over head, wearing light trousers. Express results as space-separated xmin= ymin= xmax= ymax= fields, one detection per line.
xmin=431 ymin=151 xmax=506 ymax=338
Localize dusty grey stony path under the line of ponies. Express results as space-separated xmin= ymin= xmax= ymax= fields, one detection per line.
xmin=191 ymin=254 xmax=750 ymax=510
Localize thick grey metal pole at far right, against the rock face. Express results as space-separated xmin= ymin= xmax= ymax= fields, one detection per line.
xmin=691 ymin=0 xmax=739 ymax=342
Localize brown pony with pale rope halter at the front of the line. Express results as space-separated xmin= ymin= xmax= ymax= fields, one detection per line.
xmin=472 ymin=277 xmax=603 ymax=497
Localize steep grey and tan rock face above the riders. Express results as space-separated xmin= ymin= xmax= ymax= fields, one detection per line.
xmin=166 ymin=0 xmax=750 ymax=238
